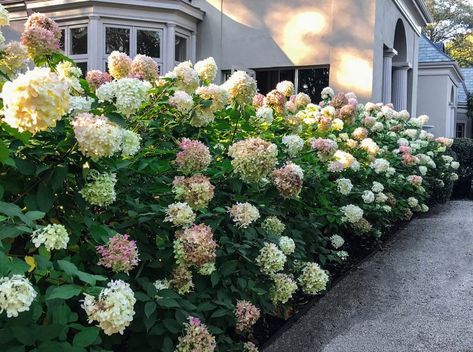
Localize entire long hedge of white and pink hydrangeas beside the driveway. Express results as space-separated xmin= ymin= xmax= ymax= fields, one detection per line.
xmin=0 ymin=11 xmax=457 ymax=351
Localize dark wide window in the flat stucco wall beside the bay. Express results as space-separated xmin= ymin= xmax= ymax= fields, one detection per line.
xmin=255 ymin=67 xmax=329 ymax=102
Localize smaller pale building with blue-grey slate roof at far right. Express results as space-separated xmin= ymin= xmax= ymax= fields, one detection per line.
xmin=417 ymin=36 xmax=462 ymax=137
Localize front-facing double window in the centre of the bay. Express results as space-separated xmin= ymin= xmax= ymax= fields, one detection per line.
xmin=103 ymin=25 xmax=163 ymax=70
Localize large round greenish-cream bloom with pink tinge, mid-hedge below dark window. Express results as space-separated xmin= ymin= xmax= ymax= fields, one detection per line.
xmin=228 ymin=138 xmax=278 ymax=183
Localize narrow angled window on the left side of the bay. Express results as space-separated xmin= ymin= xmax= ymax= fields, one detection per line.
xmin=60 ymin=24 xmax=88 ymax=75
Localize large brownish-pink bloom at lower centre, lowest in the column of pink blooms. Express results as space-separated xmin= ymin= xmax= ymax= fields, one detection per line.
xmin=176 ymin=224 xmax=217 ymax=268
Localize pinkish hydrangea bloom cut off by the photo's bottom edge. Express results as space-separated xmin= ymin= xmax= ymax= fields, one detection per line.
xmin=176 ymin=317 xmax=217 ymax=352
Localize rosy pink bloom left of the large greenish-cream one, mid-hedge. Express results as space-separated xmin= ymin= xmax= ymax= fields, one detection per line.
xmin=175 ymin=138 xmax=212 ymax=175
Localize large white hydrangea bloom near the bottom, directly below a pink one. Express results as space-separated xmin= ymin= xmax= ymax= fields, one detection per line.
xmin=82 ymin=280 xmax=136 ymax=336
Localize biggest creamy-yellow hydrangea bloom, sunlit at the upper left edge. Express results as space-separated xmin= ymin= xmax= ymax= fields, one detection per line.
xmin=1 ymin=67 xmax=69 ymax=134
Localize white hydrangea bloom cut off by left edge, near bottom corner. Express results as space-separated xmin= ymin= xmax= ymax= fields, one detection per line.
xmin=0 ymin=275 xmax=37 ymax=318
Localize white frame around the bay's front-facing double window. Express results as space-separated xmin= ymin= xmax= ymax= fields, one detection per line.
xmin=101 ymin=22 xmax=164 ymax=72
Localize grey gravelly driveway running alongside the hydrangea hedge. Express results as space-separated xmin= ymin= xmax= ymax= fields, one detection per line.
xmin=264 ymin=201 xmax=473 ymax=352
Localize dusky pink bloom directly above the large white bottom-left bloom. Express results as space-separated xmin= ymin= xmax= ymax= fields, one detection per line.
xmin=97 ymin=234 xmax=139 ymax=274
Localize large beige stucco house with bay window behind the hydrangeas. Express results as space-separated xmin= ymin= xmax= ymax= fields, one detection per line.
xmin=1 ymin=0 xmax=431 ymax=114
